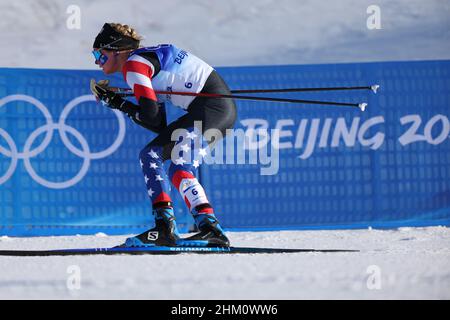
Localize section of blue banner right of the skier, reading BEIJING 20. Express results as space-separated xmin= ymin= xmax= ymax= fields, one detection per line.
xmin=202 ymin=61 xmax=450 ymax=230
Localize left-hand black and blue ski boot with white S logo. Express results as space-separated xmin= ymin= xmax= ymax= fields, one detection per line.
xmin=124 ymin=208 xmax=180 ymax=247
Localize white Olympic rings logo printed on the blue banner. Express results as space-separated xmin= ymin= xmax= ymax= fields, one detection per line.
xmin=0 ymin=94 xmax=126 ymax=189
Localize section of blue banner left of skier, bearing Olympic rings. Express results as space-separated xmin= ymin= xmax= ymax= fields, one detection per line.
xmin=0 ymin=69 xmax=192 ymax=236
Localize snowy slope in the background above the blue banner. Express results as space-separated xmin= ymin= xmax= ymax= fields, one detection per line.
xmin=0 ymin=0 xmax=450 ymax=69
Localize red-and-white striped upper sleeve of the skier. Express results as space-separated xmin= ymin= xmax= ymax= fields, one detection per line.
xmin=122 ymin=55 xmax=157 ymax=103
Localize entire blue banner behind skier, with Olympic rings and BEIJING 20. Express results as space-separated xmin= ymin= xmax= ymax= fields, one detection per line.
xmin=0 ymin=61 xmax=450 ymax=236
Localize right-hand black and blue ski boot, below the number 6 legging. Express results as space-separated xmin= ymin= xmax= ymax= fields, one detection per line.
xmin=181 ymin=214 xmax=230 ymax=247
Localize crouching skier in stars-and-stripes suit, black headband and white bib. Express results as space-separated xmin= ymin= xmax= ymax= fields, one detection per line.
xmin=91 ymin=23 xmax=236 ymax=246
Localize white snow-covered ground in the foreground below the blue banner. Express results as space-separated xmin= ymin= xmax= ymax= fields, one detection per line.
xmin=0 ymin=227 xmax=450 ymax=300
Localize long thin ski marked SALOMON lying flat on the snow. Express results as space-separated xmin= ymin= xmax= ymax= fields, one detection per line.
xmin=0 ymin=246 xmax=359 ymax=257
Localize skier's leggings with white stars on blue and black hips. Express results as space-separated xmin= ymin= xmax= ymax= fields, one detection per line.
xmin=139 ymin=71 xmax=236 ymax=213
